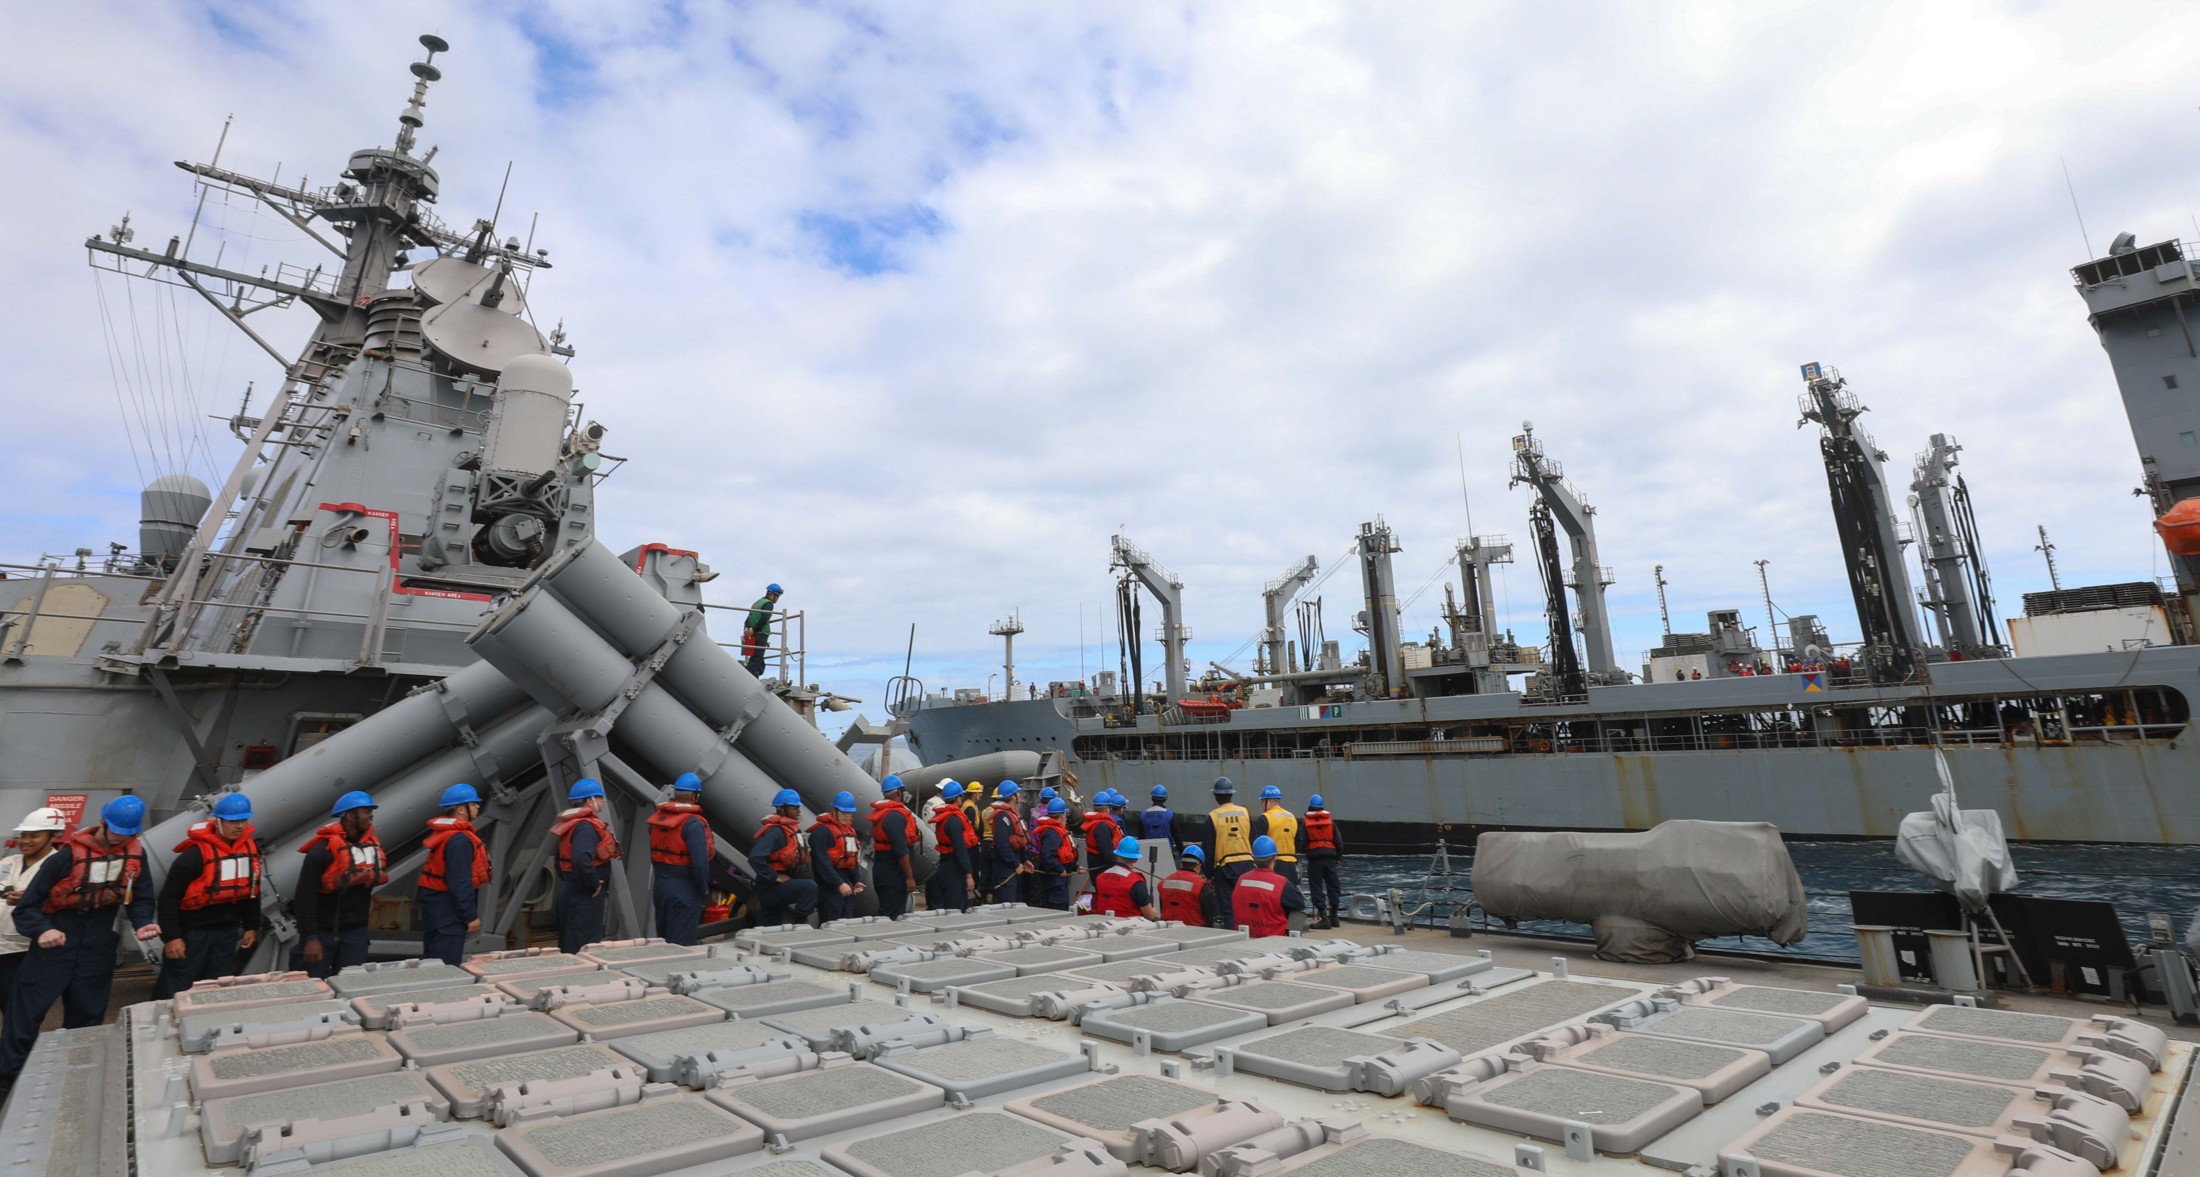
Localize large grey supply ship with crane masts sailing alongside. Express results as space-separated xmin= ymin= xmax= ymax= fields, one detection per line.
xmin=895 ymin=255 xmax=2200 ymax=851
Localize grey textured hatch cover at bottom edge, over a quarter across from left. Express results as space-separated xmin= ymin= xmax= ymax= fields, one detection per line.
xmin=497 ymin=1096 xmax=763 ymax=1177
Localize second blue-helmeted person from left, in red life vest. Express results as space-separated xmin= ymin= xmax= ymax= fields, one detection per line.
xmin=152 ymin=792 xmax=264 ymax=1001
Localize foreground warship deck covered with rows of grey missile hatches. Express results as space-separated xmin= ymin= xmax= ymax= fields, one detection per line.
xmin=21 ymin=915 xmax=2200 ymax=1177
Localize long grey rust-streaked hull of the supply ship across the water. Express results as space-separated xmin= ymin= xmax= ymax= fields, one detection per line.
xmin=906 ymin=647 xmax=2200 ymax=851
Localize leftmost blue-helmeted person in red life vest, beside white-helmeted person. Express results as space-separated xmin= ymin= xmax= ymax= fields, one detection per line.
xmin=0 ymin=794 xmax=161 ymax=1098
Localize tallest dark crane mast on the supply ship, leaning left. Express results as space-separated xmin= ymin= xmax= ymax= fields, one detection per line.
xmin=1797 ymin=363 xmax=1918 ymax=682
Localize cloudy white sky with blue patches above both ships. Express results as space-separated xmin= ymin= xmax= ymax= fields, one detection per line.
xmin=0 ymin=0 xmax=2200 ymax=717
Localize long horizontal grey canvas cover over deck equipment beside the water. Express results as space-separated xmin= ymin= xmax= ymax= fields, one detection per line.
xmin=1478 ymin=821 xmax=1808 ymax=964
